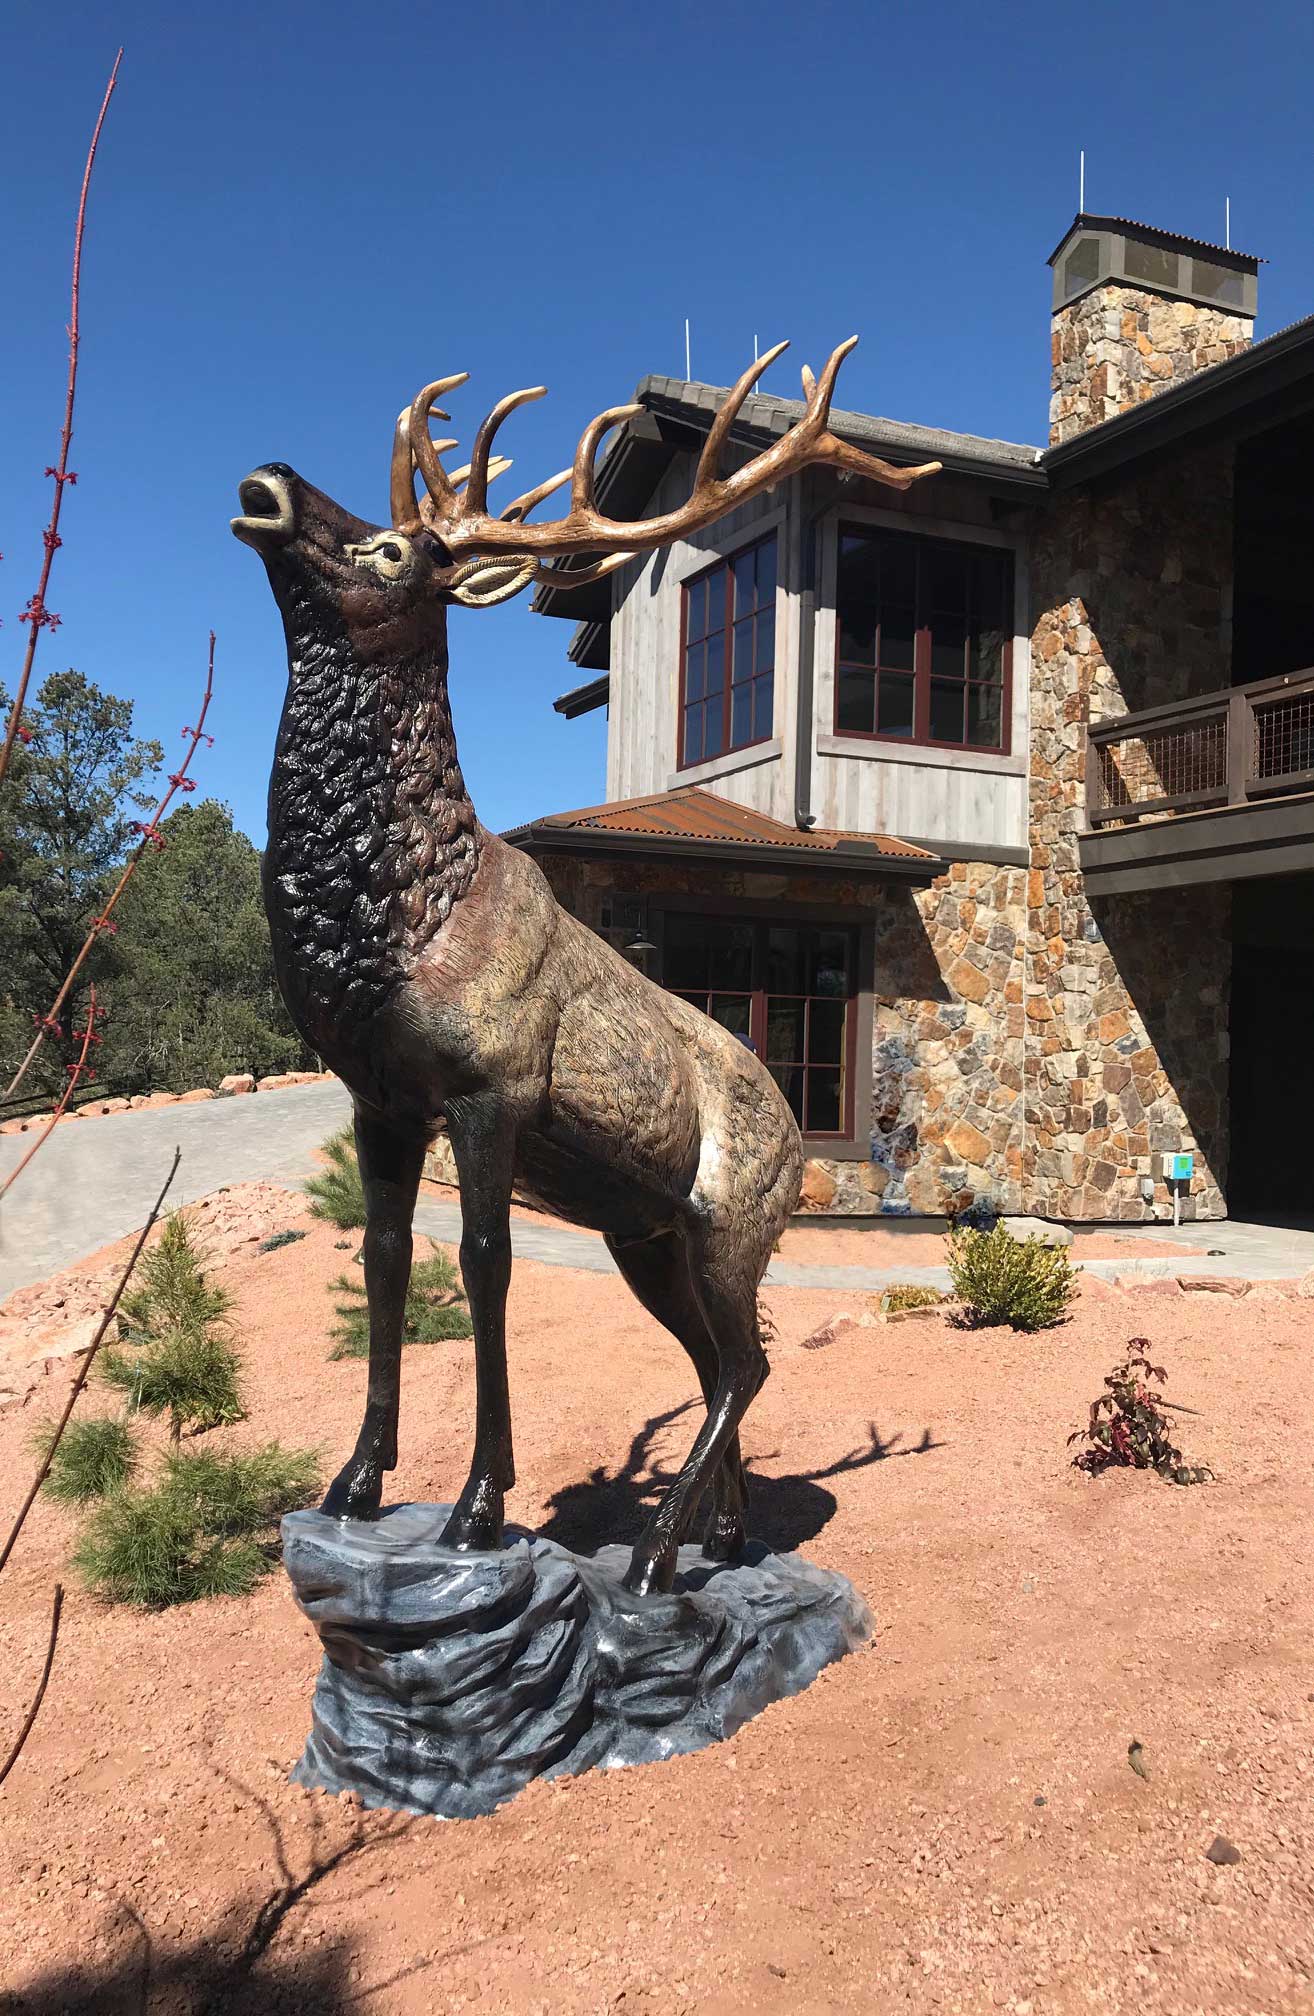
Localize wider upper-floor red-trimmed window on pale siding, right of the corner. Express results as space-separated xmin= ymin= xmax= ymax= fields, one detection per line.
xmin=834 ymin=524 xmax=1014 ymax=754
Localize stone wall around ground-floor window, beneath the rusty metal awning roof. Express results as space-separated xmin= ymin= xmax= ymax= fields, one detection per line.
xmin=523 ymin=855 xmax=1026 ymax=1216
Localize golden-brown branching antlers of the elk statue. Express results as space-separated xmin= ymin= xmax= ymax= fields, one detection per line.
xmin=391 ymin=337 xmax=939 ymax=587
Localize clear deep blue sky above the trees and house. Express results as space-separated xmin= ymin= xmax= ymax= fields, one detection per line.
xmin=0 ymin=0 xmax=1314 ymax=841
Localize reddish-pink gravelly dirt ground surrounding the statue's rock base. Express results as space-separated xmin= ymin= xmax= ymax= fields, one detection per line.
xmin=0 ymin=1218 xmax=1314 ymax=2016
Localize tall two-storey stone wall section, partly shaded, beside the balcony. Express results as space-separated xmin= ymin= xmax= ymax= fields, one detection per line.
xmin=1024 ymin=450 xmax=1231 ymax=1220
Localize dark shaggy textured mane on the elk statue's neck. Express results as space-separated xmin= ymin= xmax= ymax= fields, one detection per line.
xmin=264 ymin=585 xmax=480 ymax=1056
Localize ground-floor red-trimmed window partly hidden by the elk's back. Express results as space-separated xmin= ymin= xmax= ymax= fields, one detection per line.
xmin=663 ymin=911 xmax=857 ymax=1139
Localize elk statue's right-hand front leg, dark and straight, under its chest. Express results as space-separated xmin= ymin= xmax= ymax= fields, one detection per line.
xmin=443 ymin=1097 xmax=516 ymax=1552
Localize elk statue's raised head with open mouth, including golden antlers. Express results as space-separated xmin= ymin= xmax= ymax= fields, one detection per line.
xmin=232 ymin=337 xmax=939 ymax=641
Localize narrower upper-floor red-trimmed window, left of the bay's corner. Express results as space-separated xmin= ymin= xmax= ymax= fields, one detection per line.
xmin=679 ymin=532 xmax=776 ymax=770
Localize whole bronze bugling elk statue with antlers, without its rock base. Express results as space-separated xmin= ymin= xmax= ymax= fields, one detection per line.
xmin=232 ymin=337 xmax=937 ymax=1593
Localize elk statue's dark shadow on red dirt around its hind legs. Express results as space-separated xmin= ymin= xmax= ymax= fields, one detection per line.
xmin=536 ymin=1399 xmax=943 ymax=1554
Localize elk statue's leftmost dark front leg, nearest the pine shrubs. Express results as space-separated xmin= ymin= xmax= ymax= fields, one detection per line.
xmin=322 ymin=1111 xmax=425 ymax=1518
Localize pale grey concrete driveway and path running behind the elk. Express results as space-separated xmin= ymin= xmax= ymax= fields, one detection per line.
xmin=0 ymin=1083 xmax=1314 ymax=1298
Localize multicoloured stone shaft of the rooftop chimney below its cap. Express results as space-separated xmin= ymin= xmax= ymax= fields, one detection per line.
xmin=1050 ymin=282 xmax=1256 ymax=446
